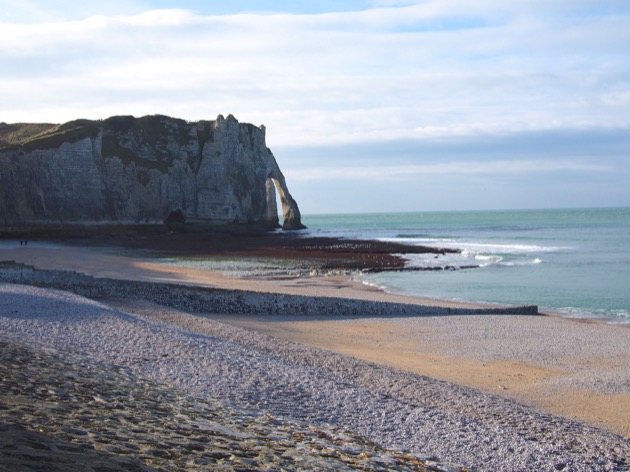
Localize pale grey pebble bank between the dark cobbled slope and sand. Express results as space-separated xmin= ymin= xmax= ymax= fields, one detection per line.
xmin=0 ymin=286 xmax=630 ymax=470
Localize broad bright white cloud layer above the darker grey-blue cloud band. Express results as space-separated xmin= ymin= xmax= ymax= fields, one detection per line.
xmin=0 ymin=0 xmax=630 ymax=146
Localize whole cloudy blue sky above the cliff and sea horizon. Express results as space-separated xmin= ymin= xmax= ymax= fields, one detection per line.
xmin=0 ymin=0 xmax=630 ymax=215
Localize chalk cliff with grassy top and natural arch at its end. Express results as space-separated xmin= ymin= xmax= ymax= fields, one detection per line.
xmin=0 ymin=115 xmax=304 ymax=234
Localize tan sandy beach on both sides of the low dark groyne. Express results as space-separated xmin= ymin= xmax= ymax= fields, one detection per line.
xmin=0 ymin=244 xmax=630 ymax=437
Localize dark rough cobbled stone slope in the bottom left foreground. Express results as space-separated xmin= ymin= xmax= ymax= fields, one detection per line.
xmin=0 ymin=341 xmax=459 ymax=472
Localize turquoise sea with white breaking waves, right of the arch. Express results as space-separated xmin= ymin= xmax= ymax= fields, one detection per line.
xmin=303 ymin=208 xmax=630 ymax=324
